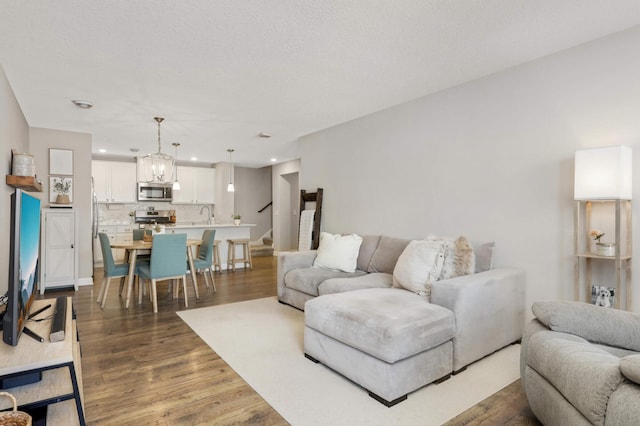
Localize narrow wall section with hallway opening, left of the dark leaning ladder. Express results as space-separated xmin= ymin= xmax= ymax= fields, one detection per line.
xmin=271 ymin=160 xmax=301 ymax=252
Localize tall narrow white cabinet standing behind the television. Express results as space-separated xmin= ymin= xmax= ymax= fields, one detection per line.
xmin=40 ymin=209 xmax=78 ymax=294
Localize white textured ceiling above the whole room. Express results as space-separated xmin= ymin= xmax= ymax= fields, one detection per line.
xmin=0 ymin=0 xmax=640 ymax=166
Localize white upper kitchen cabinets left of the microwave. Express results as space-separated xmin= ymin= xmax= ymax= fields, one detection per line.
xmin=91 ymin=160 xmax=136 ymax=203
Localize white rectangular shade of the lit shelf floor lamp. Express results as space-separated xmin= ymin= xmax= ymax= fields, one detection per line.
xmin=573 ymin=145 xmax=632 ymax=200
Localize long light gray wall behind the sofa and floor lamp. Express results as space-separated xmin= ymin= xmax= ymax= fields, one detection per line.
xmin=300 ymin=27 xmax=640 ymax=315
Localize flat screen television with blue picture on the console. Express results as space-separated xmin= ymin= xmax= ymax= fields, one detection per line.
xmin=2 ymin=189 xmax=40 ymax=346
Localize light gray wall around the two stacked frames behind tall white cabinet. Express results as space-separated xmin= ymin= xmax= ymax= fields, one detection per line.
xmin=29 ymin=127 xmax=93 ymax=285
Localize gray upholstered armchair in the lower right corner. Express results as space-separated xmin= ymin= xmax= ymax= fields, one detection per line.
xmin=520 ymin=301 xmax=640 ymax=426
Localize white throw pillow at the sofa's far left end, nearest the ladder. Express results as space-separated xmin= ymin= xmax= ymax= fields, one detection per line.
xmin=313 ymin=232 xmax=362 ymax=272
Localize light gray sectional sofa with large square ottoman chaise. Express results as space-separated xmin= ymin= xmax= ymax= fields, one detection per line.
xmin=277 ymin=235 xmax=525 ymax=406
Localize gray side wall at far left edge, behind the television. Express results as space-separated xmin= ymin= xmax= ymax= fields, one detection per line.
xmin=0 ymin=65 xmax=29 ymax=295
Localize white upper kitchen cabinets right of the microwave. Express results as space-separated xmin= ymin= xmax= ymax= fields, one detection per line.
xmin=173 ymin=166 xmax=215 ymax=204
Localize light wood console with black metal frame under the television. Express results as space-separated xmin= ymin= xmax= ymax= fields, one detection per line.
xmin=0 ymin=297 xmax=86 ymax=426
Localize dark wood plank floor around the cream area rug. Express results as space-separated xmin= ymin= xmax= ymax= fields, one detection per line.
xmin=37 ymin=256 xmax=539 ymax=425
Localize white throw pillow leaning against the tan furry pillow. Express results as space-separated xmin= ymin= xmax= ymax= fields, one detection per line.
xmin=393 ymin=240 xmax=444 ymax=297
